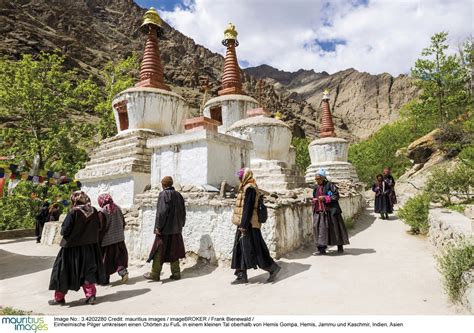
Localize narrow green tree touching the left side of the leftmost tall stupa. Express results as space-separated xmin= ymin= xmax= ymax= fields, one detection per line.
xmin=94 ymin=53 xmax=139 ymax=139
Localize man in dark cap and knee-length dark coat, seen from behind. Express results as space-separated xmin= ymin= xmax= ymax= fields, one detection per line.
xmin=143 ymin=176 xmax=186 ymax=281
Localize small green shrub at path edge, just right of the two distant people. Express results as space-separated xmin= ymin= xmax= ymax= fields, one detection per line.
xmin=397 ymin=193 xmax=430 ymax=235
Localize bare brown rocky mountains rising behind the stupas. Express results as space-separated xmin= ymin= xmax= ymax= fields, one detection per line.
xmin=0 ymin=0 xmax=416 ymax=140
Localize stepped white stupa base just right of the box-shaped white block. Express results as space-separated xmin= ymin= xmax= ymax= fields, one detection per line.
xmin=250 ymin=159 xmax=306 ymax=192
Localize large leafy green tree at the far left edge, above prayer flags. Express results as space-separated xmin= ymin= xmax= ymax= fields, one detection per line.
xmin=0 ymin=52 xmax=100 ymax=174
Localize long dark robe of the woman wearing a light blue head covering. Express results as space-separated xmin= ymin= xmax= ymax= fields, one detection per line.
xmin=313 ymin=181 xmax=349 ymax=247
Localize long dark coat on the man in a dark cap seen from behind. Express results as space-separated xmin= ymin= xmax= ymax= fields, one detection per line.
xmin=147 ymin=187 xmax=186 ymax=263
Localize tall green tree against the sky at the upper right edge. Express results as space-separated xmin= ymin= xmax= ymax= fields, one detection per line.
xmin=410 ymin=32 xmax=472 ymax=127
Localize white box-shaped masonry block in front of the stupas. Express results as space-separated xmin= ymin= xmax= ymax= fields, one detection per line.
xmin=148 ymin=127 xmax=252 ymax=189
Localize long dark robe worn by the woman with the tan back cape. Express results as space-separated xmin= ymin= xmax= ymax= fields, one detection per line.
xmin=231 ymin=186 xmax=274 ymax=270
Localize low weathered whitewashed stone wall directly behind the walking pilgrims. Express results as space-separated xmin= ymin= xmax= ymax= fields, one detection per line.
xmin=126 ymin=189 xmax=363 ymax=263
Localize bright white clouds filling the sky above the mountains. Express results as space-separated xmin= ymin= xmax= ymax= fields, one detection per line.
xmin=160 ymin=0 xmax=473 ymax=75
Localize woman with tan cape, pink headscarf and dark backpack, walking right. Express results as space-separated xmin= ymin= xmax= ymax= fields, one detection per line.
xmin=231 ymin=168 xmax=281 ymax=284
